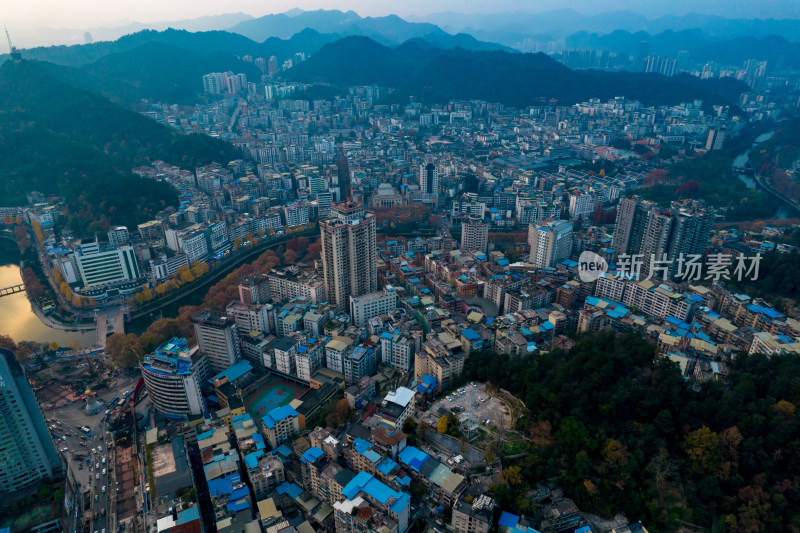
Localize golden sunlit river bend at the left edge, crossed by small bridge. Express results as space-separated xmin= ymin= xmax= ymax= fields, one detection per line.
xmin=0 ymin=239 xmax=95 ymax=347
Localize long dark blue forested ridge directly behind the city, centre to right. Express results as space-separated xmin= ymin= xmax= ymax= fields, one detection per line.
xmin=285 ymin=37 xmax=748 ymax=109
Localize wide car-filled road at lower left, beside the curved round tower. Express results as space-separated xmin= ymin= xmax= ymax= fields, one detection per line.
xmin=48 ymin=376 xmax=139 ymax=533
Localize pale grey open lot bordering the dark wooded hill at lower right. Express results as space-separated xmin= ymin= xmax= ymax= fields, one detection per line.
xmin=424 ymin=383 xmax=509 ymax=429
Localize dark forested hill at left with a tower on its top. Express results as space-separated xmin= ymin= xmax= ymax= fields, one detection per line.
xmin=0 ymin=61 xmax=239 ymax=234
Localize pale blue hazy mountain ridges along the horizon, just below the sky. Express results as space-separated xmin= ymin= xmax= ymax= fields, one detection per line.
xmin=11 ymin=7 xmax=800 ymax=60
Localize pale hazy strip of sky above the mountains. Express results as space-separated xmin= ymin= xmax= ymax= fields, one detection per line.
xmin=0 ymin=0 xmax=800 ymax=28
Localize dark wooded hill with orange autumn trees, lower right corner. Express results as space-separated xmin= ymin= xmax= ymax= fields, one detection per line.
xmin=456 ymin=332 xmax=800 ymax=532
